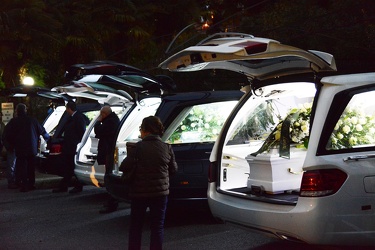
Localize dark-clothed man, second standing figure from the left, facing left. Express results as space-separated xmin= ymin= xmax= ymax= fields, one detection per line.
xmin=52 ymin=101 xmax=86 ymax=194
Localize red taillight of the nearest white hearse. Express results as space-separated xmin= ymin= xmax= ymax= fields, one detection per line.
xmin=300 ymin=169 xmax=348 ymax=197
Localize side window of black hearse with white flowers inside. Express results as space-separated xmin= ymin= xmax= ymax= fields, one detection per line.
xmin=166 ymin=101 xmax=237 ymax=144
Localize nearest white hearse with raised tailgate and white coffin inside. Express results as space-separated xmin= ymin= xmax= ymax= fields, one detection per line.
xmin=160 ymin=33 xmax=375 ymax=246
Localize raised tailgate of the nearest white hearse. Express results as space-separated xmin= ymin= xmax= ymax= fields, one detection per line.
xmin=159 ymin=33 xmax=336 ymax=80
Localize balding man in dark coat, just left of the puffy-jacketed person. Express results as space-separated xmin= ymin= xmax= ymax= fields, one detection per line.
xmin=94 ymin=106 xmax=120 ymax=213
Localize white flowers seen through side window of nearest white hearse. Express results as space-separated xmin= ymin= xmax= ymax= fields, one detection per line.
xmin=331 ymin=108 xmax=375 ymax=149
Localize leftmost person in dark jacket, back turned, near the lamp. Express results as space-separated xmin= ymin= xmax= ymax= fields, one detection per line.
xmin=4 ymin=103 xmax=49 ymax=192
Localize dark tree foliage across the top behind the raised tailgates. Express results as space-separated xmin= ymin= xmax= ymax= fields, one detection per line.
xmin=0 ymin=0 xmax=375 ymax=91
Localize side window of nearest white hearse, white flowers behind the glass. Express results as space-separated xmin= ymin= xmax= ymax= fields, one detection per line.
xmin=326 ymin=91 xmax=375 ymax=150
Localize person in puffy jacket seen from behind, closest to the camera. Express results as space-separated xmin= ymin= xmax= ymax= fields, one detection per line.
xmin=121 ymin=116 xmax=177 ymax=250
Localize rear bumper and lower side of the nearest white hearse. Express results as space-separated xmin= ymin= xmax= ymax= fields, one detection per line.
xmin=208 ymin=183 xmax=375 ymax=246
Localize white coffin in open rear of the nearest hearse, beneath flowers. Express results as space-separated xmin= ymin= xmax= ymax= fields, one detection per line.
xmin=245 ymin=148 xmax=306 ymax=193
